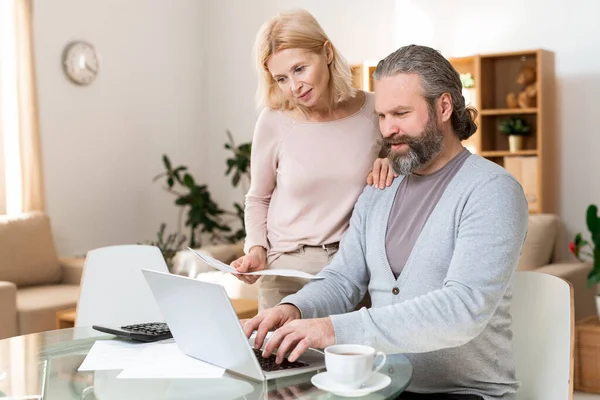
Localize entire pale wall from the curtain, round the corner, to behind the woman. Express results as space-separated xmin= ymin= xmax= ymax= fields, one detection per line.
xmin=34 ymin=0 xmax=394 ymax=254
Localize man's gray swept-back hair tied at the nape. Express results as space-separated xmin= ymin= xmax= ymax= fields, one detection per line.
xmin=373 ymin=44 xmax=477 ymax=140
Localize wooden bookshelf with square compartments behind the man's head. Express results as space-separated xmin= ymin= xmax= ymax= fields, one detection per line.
xmin=449 ymin=49 xmax=557 ymax=214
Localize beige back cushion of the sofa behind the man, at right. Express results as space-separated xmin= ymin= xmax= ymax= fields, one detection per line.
xmin=518 ymin=214 xmax=559 ymax=271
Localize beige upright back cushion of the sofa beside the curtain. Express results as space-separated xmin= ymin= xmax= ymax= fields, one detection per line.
xmin=0 ymin=212 xmax=61 ymax=286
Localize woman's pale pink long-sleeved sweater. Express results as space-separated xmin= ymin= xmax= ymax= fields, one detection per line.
xmin=244 ymin=93 xmax=381 ymax=254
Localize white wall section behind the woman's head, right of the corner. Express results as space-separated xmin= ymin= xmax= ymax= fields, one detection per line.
xmin=203 ymin=0 xmax=394 ymax=214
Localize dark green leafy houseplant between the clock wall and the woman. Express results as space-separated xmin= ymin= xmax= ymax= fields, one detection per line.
xmin=149 ymin=130 xmax=252 ymax=267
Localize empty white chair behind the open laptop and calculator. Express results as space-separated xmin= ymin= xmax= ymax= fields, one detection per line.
xmin=75 ymin=245 xmax=169 ymax=326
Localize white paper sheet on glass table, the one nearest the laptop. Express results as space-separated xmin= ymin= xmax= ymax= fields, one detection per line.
xmin=117 ymin=343 xmax=225 ymax=379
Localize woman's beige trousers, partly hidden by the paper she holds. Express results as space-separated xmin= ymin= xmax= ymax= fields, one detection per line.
xmin=258 ymin=247 xmax=337 ymax=311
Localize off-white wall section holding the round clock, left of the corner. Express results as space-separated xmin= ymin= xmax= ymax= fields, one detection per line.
xmin=34 ymin=0 xmax=205 ymax=255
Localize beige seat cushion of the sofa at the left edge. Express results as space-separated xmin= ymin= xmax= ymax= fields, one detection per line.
xmin=17 ymin=285 xmax=80 ymax=335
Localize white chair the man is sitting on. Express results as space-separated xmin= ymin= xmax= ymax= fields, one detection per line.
xmin=511 ymin=271 xmax=575 ymax=400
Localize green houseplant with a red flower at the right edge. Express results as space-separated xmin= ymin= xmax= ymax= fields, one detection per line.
xmin=569 ymin=204 xmax=600 ymax=287
